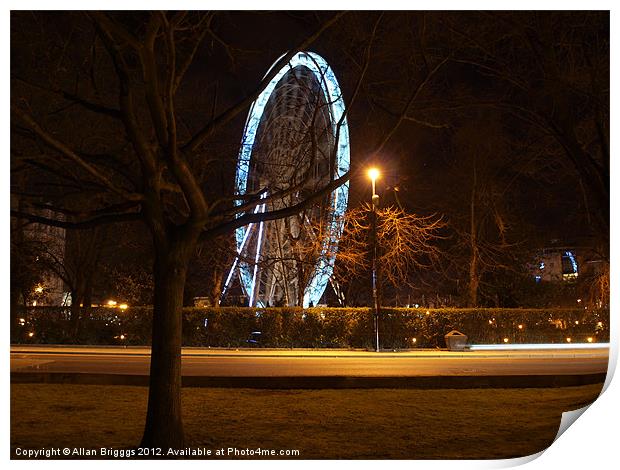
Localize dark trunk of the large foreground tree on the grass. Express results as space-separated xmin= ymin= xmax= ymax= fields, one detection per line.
xmin=140 ymin=244 xmax=188 ymax=449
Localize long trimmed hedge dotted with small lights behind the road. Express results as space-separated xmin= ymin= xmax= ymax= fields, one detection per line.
xmin=12 ymin=307 xmax=609 ymax=349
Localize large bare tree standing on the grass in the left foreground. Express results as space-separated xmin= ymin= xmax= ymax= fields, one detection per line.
xmin=11 ymin=12 xmax=349 ymax=448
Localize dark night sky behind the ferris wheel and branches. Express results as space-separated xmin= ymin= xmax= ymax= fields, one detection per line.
xmin=11 ymin=11 xmax=609 ymax=304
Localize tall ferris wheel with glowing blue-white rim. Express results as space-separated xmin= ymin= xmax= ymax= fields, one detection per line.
xmin=222 ymin=52 xmax=350 ymax=307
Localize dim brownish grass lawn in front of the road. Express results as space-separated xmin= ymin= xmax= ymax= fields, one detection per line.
xmin=11 ymin=384 xmax=602 ymax=459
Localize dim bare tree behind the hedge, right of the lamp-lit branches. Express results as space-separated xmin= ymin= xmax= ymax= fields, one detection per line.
xmin=426 ymin=119 xmax=533 ymax=307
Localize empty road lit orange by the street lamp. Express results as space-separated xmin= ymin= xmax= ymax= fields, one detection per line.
xmin=11 ymin=346 xmax=608 ymax=377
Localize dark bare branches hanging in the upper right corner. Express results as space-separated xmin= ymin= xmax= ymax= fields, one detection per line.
xmin=407 ymin=11 xmax=610 ymax=233
